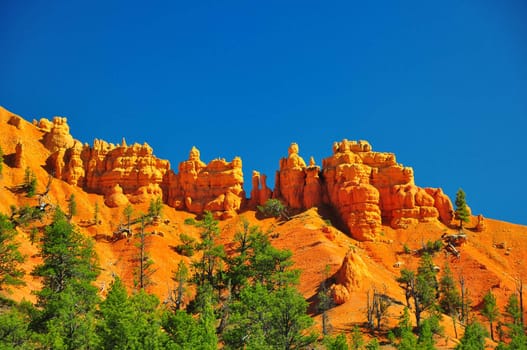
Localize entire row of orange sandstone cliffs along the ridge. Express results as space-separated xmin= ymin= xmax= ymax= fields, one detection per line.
xmin=13 ymin=112 xmax=453 ymax=240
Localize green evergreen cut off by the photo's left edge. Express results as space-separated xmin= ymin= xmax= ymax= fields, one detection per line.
xmin=0 ymin=214 xmax=25 ymax=292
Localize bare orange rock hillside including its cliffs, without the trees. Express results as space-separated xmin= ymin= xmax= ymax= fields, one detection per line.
xmin=0 ymin=108 xmax=527 ymax=349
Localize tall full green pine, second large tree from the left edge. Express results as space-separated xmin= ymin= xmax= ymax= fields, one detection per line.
xmin=32 ymin=208 xmax=99 ymax=349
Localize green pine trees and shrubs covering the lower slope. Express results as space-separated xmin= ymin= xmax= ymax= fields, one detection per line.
xmin=0 ymin=196 xmax=527 ymax=350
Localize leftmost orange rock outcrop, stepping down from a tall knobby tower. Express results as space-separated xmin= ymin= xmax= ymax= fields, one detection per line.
xmin=37 ymin=117 xmax=170 ymax=206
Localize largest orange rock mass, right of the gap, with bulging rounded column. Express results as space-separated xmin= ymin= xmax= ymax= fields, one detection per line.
xmin=273 ymin=140 xmax=453 ymax=240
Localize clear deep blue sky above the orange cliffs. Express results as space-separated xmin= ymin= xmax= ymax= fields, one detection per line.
xmin=0 ymin=0 xmax=527 ymax=225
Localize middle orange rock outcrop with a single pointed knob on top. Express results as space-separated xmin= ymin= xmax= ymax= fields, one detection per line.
xmin=167 ymin=147 xmax=245 ymax=217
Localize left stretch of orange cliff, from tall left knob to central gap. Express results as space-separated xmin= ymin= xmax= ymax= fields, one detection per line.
xmin=37 ymin=117 xmax=245 ymax=217
